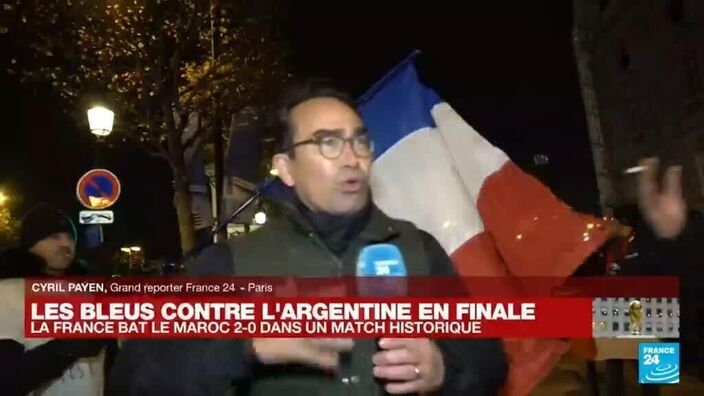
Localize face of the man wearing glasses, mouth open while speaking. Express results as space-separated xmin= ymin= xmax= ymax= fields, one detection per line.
xmin=274 ymin=98 xmax=372 ymax=214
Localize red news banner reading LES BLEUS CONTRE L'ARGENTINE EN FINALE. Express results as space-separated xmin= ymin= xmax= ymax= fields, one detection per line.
xmin=25 ymin=278 xmax=676 ymax=338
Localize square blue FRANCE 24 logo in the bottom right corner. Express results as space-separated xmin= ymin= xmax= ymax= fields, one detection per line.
xmin=638 ymin=342 xmax=680 ymax=384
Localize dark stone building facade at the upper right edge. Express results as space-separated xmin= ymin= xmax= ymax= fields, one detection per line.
xmin=574 ymin=0 xmax=704 ymax=210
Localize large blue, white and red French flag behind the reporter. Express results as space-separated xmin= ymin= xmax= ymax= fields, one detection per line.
xmin=358 ymin=52 xmax=607 ymax=395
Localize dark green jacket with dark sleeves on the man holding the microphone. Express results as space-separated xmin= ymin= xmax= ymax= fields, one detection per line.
xmin=111 ymin=203 xmax=507 ymax=396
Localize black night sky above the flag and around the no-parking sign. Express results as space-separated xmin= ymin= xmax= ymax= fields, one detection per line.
xmin=0 ymin=0 xmax=598 ymax=258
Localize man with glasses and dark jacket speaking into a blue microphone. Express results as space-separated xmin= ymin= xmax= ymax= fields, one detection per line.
xmin=111 ymin=84 xmax=507 ymax=395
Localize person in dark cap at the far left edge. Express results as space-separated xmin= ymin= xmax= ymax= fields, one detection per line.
xmin=0 ymin=204 xmax=114 ymax=395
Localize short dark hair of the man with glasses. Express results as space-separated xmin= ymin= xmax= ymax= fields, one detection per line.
xmin=274 ymin=78 xmax=357 ymax=156
